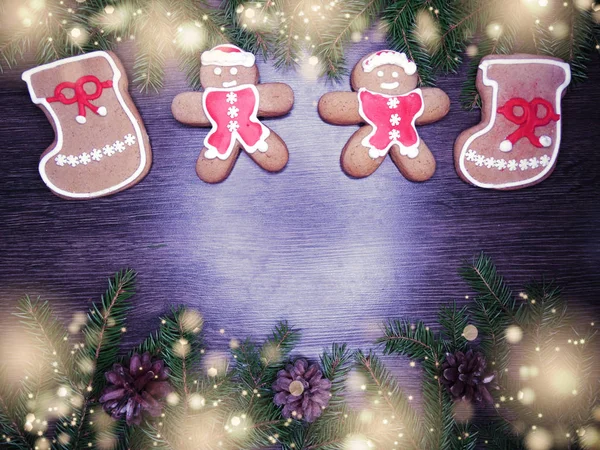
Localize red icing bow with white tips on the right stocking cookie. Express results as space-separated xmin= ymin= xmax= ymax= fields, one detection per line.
xmin=498 ymin=98 xmax=560 ymax=152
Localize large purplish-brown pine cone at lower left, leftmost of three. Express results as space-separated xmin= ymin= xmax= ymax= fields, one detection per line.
xmin=100 ymin=353 xmax=171 ymax=425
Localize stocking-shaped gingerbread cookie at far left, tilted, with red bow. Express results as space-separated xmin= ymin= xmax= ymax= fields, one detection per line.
xmin=22 ymin=51 xmax=152 ymax=199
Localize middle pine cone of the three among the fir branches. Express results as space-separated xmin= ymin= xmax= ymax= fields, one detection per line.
xmin=273 ymin=359 xmax=331 ymax=422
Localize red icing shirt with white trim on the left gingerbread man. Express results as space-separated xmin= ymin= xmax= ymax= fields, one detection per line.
xmin=202 ymin=84 xmax=270 ymax=160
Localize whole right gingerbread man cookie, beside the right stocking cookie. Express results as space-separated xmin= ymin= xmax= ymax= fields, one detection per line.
xmin=319 ymin=50 xmax=450 ymax=181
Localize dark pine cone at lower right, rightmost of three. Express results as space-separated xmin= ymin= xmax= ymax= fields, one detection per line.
xmin=441 ymin=350 xmax=497 ymax=403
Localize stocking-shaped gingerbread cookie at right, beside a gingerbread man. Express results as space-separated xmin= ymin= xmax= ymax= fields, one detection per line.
xmin=454 ymin=55 xmax=571 ymax=190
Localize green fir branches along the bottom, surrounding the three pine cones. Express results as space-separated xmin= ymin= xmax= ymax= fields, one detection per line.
xmin=0 ymin=254 xmax=599 ymax=450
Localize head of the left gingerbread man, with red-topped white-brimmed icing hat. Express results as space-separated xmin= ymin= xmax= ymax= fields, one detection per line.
xmin=200 ymin=44 xmax=258 ymax=89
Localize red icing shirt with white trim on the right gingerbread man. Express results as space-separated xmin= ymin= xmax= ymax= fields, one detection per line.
xmin=358 ymin=88 xmax=425 ymax=159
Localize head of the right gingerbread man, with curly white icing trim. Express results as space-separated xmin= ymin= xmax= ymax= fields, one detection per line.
xmin=350 ymin=50 xmax=419 ymax=95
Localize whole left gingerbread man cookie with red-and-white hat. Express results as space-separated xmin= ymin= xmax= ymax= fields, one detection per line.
xmin=171 ymin=44 xmax=294 ymax=183
